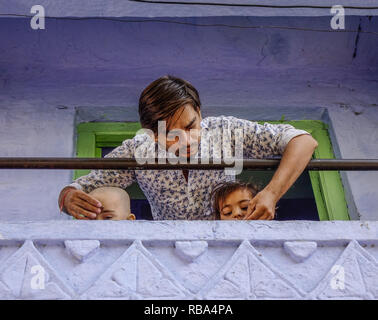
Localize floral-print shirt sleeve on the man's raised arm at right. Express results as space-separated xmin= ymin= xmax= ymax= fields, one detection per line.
xmin=219 ymin=116 xmax=309 ymax=159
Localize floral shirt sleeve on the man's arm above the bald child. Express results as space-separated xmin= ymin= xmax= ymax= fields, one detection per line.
xmin=69 ymin=139 xmax=136 ymax=193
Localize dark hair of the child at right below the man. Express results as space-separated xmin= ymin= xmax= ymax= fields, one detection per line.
xmin=210 ymin=181 xmax=259 ymax=220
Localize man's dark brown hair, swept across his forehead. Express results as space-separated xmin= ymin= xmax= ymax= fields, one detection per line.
xmin=139 ymin=75 xmax=201 ymax=133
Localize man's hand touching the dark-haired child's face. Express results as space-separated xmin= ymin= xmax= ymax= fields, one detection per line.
xmin=243 ymin=189 xmax=277 ymax=220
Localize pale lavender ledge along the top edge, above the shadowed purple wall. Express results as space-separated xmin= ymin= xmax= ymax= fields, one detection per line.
xmin=0 ymin=0 xmax=378 ymax=17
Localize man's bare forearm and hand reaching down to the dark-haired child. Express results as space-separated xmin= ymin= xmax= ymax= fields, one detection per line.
xmin=244 ymin=134 xmax=318 ymax=220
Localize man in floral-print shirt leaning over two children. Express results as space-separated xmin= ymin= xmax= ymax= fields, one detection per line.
xmin=58 ymin=76 xmax=317 ymax=220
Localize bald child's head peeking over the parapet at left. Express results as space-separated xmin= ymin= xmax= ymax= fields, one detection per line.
xmin=89 ymin=187 xmax=135 ymax=220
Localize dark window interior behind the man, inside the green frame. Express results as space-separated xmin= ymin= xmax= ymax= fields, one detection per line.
xmin=101 ymin=147 xmax=319 ymax=221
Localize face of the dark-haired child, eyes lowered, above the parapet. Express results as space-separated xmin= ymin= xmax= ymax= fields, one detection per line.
xmin=219 ymin=188 xmax=253 ymax=220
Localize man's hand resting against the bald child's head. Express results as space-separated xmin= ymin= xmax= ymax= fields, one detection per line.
xmin=63 ymin=188 xmax=102 ymax=220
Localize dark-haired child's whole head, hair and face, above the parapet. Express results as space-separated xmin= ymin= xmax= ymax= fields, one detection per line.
xmin=210 ymin=181 xmax=258 ymax=220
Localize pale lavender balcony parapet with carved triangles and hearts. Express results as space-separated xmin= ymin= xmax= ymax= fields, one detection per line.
xmin=0 ymin=221 xmax=378 ymax=299
